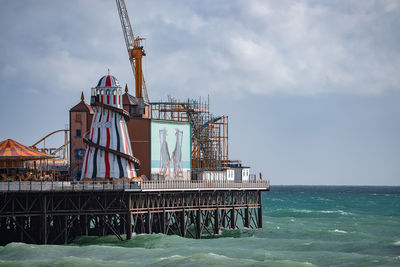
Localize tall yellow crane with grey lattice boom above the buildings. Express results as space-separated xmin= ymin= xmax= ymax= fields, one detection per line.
xmin=115 ymin=0 xmax=149 ymax=104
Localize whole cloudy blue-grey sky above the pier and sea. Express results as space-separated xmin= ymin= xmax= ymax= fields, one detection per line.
xmin=0 ymin=0 xmax=400 ymax=185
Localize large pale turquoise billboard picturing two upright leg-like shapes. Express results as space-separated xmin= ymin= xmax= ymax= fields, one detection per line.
xmin=151 ymin=120 xmax=191 ymax=180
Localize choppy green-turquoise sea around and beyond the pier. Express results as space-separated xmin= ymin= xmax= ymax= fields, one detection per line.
xmin=0 ymin=186 xmax=400 ymax=267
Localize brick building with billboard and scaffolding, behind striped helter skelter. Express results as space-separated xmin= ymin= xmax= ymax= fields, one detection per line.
xmin=70 ymin=86 xmax=250 ymax=181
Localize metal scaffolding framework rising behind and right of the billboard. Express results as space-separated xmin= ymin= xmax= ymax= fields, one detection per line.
xmin=149 ymin=98 xmax=229 ymax=174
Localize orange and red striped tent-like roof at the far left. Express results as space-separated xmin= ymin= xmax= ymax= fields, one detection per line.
xmin=0 ymin=139 xmax=55 ymax=160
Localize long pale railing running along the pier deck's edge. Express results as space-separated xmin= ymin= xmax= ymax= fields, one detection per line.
xmin=0 ymin=180 xmax=269 ymax=192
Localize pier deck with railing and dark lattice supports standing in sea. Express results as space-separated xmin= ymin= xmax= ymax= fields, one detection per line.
xmin=0 ymin=181 xmax=269 ymax=245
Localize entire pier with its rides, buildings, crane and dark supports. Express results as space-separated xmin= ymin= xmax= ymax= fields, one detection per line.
xmin=0 ymin=0 xmax=269 ymax=245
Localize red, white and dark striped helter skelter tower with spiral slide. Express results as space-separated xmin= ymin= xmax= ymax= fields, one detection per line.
xmin=81 ymin=75 xmax=140 ymax=179
